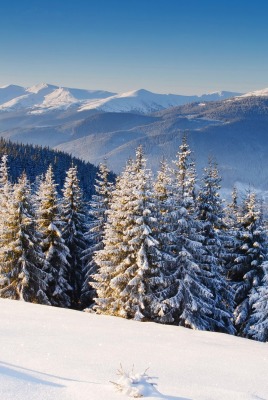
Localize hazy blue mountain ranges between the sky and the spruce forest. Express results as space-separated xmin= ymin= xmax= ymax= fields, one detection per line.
xmin=0 ymin=84 xmax=268 ymax=190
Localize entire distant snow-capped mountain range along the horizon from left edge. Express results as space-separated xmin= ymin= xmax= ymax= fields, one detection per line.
xmin=0 ymin=83 xmax=240 ymax=114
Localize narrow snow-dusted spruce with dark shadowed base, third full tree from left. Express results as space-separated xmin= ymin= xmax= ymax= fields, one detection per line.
xmin=61 ymin=165 xmax=87 ymax=309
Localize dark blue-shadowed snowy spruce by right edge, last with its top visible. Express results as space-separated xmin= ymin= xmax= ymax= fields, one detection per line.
xmin=228 ymin=193 xmax=267 ymax=337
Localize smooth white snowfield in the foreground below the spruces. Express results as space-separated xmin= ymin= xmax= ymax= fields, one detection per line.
xmin=0 ymin=299 xmax=268 ymax=400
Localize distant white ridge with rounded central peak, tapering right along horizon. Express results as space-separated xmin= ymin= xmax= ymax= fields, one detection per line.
xmin=79 ymin=89 xmax=241 ymax=114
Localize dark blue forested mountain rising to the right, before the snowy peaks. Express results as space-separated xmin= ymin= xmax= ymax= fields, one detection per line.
xmin=51 ymin=96 xmax=268 ymax=191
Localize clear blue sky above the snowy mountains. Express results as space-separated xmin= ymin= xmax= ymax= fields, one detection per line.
xmin=0 ymin=0 xmax=268 ymax=94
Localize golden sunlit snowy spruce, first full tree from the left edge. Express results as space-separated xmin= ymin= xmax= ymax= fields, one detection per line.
xmin=0 ymin=175 xmax=50 ymax=304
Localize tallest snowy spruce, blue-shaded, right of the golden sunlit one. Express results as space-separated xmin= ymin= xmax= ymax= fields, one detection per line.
xmin=155 ymin=137 xmax=230 ymax=331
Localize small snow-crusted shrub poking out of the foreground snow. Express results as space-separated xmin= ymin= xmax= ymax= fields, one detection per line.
xmin=111 ymin=365 xmax=156 ymax=398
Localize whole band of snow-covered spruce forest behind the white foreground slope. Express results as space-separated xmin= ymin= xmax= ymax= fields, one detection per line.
xmin=0 ymin=136 xmax=268 ymax=341
